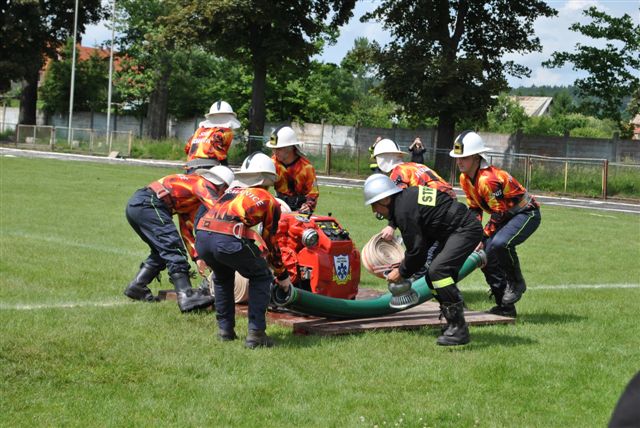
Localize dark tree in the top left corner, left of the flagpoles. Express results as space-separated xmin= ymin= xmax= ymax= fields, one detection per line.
xmin=0 ymin=0 xmax=103 ymax=125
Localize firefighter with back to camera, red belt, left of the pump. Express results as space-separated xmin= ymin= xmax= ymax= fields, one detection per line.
xmin=196 ymin=152 xmax=291 ymax=348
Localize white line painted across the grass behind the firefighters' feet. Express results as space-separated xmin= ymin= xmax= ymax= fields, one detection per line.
xmin=0 ymin=284 xmax=640 ymax=311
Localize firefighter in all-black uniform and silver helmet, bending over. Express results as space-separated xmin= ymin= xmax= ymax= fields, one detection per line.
xmin=364 ymin=174 xmax=482 ymax=346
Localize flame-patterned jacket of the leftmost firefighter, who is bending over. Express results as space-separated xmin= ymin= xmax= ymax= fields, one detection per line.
xmin=148 ymin=174 xmax=218 ymax=260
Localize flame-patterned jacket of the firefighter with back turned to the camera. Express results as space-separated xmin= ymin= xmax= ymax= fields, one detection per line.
xmin=198 ymin=187 xmax=288 ymax=278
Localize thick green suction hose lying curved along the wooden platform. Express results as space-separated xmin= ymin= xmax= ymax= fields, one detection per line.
xmin=271 ymin=251 xmax=486 ymax=319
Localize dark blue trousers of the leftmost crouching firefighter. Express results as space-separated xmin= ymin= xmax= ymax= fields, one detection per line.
xmin=125 ymin=189 xmax=190 ymax=274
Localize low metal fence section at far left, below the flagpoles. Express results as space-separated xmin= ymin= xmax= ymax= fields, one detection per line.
xmin=15 ymin=125 xmax=133 ymax=156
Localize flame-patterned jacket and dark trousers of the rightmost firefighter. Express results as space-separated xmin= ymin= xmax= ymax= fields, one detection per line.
xmin=460 ymin=166 xmax=540 ymax=289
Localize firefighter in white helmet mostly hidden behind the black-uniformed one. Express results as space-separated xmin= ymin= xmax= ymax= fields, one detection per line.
xmin=373 ymin=138 xmax=457 ymax=242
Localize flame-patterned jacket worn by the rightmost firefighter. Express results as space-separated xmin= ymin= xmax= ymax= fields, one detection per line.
xmin=460 ymin=165 xmax=540 ymax=236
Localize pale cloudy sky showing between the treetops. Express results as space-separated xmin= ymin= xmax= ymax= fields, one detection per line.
xmin=83 ymin=0 xmax=640 ymax=87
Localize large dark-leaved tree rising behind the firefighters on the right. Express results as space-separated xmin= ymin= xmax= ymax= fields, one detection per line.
xmin=362 ymin=0 xmax=557 ymax=168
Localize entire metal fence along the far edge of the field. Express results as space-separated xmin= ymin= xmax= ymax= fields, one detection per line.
xmin=5 ymin=125 xmax=640 ymax=200
